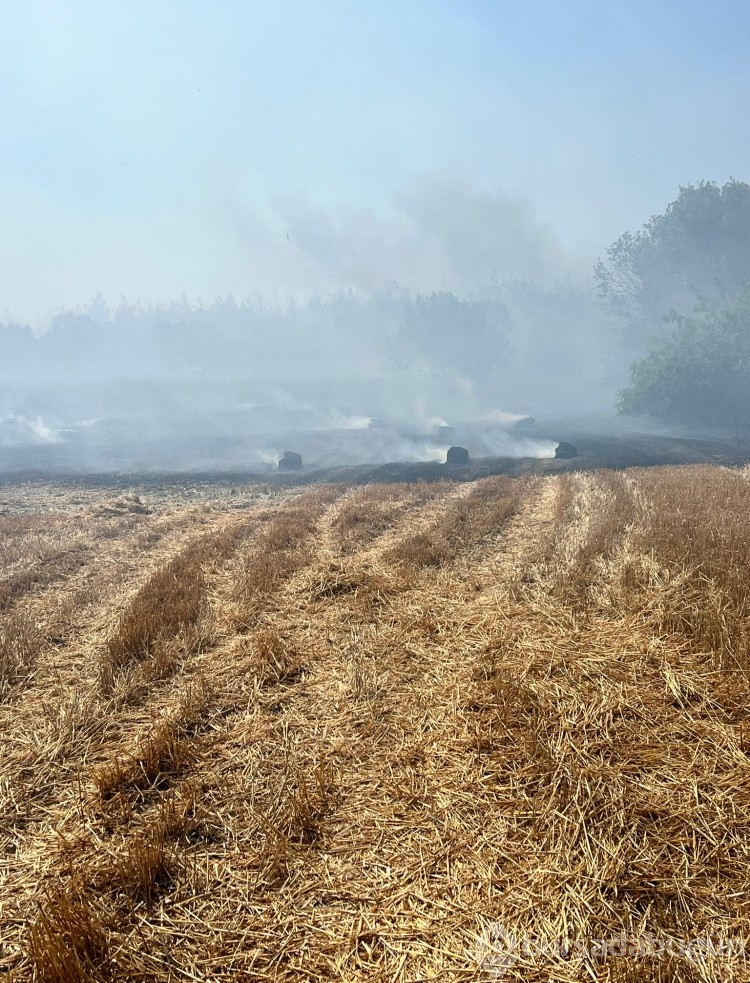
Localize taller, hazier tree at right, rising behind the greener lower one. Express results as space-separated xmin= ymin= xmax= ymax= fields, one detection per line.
xmin=594 ymin=179 xmax=750 ymax=338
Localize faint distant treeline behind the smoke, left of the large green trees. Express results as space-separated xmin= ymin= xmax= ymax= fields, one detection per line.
xmin=0 ymin=283 xmax=604 ymax=391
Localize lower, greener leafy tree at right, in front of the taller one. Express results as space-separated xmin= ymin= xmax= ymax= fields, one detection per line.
xmin=618 ymin=287 xmax=750 ymax=429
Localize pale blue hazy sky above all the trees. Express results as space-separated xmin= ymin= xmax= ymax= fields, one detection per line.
xmin=0 ymin=0 xmax=750 ymax=320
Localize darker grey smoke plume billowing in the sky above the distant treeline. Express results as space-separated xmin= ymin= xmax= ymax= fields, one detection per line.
xmin=268 ymin=177 xmax=571 ymax=296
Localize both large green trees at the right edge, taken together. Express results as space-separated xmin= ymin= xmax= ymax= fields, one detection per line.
xmin=595 ymin=180 xmax=750 ymax=433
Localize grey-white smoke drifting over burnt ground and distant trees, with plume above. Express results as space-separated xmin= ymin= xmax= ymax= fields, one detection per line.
xmin=0 ymin=178 xmax=632 ymax=470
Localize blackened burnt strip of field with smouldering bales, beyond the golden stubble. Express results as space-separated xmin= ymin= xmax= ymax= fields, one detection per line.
xmin=0 ymin=425 xmax=750 ymax=492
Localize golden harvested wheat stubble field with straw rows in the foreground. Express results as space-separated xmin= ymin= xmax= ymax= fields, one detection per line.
xmin=0 ymin=465 xmax=750 ymax=983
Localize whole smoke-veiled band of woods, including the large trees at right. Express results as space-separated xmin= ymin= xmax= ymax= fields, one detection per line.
xmin=5 ymin=180 xmax=750 ymax=429
